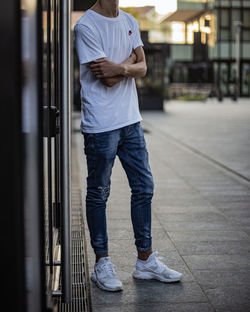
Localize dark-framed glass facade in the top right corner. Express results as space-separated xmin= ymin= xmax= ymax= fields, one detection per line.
xmin=211 ymin=0 xmax=250 ymax=96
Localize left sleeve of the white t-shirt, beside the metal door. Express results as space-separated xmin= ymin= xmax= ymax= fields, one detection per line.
xmin=74 ymin=24 xmax=106 ymax=64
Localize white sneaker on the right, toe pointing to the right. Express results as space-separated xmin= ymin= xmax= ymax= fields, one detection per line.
xmin=133 ymin=251 xmax=182 ymax=283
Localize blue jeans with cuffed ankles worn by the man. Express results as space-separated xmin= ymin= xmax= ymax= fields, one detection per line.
xmin=83 ymin=122 xmax=154 ymax=255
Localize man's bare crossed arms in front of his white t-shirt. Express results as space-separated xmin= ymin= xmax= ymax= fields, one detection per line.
xmin=90 ymin=46 xmax=147 ymax=87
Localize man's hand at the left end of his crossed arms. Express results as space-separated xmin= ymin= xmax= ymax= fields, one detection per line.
xmin=90 ymin=58 xmax=123 ymax=78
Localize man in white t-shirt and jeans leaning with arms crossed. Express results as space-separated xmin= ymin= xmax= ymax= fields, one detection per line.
xmin=75 ymin=0 xmax=182 ymax=291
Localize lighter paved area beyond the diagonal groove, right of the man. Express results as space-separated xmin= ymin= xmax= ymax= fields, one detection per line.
xmin=143 ymin=99 xmax=250 ymax=177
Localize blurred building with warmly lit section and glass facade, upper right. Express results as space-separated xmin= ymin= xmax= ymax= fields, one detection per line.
xmin=161 ymin=0 xmax=250 ymax=96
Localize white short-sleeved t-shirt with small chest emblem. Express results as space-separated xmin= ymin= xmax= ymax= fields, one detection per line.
xmin=75 ymin=10 xmax=143 ymax=133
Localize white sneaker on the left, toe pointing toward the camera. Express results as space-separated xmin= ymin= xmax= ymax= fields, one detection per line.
xmin=91 ymin=257 xmax=122 ymax=291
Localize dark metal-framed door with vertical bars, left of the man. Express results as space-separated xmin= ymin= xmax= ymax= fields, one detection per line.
xmin=43 ymin=0 xmax=72 ymax=305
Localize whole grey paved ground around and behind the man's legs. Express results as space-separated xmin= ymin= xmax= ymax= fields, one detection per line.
xmin=75 ymin=101 xmax=250 ymax=312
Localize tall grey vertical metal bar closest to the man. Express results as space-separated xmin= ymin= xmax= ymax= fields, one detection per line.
xmin=60 ymin=0 xmax=72 ymax=302
